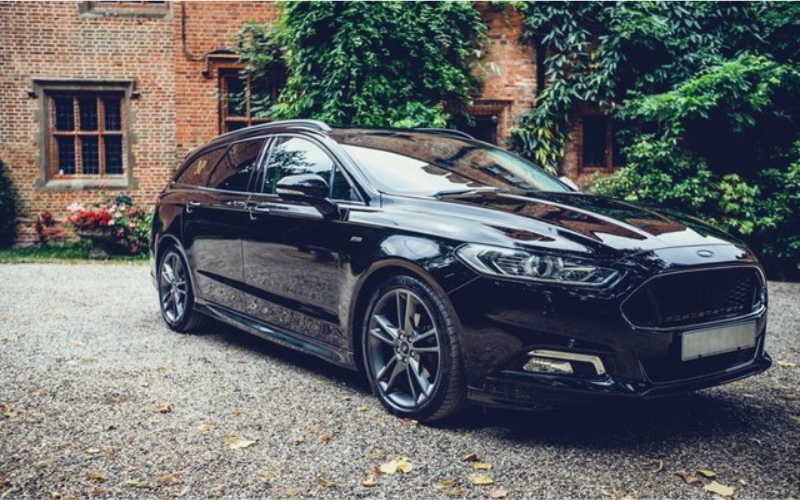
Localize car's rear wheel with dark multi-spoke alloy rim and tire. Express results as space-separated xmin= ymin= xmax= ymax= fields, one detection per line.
xmin=158 ymin=246 xmax=210 ymax=333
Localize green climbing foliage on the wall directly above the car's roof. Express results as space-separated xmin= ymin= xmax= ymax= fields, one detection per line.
xmin=240 ymin=2 xmax=486 ymax=127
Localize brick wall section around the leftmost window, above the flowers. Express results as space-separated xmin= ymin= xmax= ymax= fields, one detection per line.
xmin=0 ymin=2 xmax=176 ymax=243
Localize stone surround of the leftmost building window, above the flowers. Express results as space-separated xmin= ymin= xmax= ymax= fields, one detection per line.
xmin=29 ymin=79 xmax=139 ymax=190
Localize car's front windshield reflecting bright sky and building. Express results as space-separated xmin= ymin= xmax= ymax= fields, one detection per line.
xmin=334 ymin=130 xmax=570 ymax=195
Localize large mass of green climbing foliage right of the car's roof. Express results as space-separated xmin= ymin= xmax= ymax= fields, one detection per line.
xmin=512 ymin=2 xmax=800 ymax=275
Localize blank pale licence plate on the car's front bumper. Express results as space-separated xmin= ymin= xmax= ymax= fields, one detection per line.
xmin=681 ymin=322 xmax=756 ymax=361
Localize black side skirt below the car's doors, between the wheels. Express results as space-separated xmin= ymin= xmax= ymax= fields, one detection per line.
xmin=195 ymin=303 xmax=356 ymax=370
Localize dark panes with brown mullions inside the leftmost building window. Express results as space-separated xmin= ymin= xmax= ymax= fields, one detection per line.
xmin=48 ymin=92 xmax=125 ymax=177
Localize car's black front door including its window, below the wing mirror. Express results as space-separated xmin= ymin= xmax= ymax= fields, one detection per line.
xmin=243 ymin=136 xmax=360 ymax=347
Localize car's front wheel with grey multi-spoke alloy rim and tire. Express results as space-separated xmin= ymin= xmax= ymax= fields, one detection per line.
xmin=361 ymin=276 xmax=466 ymax=423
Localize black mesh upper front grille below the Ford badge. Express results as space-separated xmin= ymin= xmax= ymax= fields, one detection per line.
xmin=622 ymin=267 xmax=763 ymax=328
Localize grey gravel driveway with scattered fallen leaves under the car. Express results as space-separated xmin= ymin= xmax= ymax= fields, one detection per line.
xmin=0 ymin=264 xmax=800 ymax=499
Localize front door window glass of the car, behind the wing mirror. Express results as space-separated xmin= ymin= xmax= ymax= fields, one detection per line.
xmin=263 ymin=137 xmax=333 ymax=194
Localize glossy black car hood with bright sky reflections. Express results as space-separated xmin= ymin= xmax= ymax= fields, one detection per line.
xmin=382 ymin=192 xmax=741 ymax=253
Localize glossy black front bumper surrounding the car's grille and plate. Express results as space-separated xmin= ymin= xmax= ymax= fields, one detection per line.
xmin=450 ymin=252 xmax=772 ymax=408
